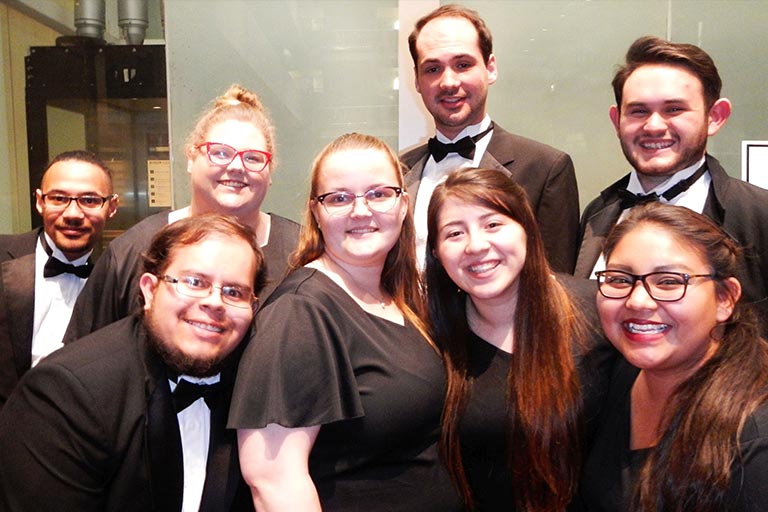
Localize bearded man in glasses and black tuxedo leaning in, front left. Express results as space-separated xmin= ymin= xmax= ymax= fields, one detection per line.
xmin=0 ymin=214 xmax=265 ymax=512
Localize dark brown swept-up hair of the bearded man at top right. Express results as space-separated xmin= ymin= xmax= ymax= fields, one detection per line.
xmin=611 ymin=36 xmax=723 ymax=110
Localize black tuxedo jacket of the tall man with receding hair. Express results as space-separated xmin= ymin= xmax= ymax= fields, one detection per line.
xmin=400 ymin=124 xmax=579 ymax=274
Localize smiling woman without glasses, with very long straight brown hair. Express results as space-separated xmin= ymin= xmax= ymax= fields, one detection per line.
xmin=426 ymin=169 xmax=594 ymax=511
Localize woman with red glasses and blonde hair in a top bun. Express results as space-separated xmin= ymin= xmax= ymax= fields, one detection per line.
xmin=64 ymin=85 xmax=299 ymax=341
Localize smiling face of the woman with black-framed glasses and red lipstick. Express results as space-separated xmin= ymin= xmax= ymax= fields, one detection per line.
xmin=597 ymin=224 xmax=738 ymax=379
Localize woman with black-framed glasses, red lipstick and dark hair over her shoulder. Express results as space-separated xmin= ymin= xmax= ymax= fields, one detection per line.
xmin=580 ymin=203 xmax=768 ymax=512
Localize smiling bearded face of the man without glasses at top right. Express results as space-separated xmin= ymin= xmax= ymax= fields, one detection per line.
xmin=609 ymin=64 xmax=730 ymax=190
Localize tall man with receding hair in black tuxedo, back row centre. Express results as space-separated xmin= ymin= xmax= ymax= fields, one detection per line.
xmin=400 ymin=5 xmax=579 ymax=273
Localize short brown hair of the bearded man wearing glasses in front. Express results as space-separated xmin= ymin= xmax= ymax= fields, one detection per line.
xmin=139 ymin=213 xmax=267 ymax=308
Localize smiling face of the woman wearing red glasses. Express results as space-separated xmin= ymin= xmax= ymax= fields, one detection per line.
xmin=187 ymin=120 xmax=272 ymax=224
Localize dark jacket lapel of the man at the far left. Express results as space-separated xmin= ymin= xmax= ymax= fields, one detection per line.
xmin=2 ymin=253 xmax=35 ymax=375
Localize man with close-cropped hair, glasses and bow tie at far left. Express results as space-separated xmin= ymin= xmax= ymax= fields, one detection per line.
xmin=0 ymin=151 xmax=118 ymax=407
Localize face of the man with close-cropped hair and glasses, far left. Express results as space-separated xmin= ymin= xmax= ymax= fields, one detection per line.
xmin=35 ymin=160 xmax=117 ymax=261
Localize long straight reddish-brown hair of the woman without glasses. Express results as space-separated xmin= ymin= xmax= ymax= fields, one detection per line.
xmin=426 ymin=169 xmax=585 ymax=511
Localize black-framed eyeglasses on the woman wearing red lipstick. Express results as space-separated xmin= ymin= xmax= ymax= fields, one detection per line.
xmin=595 ymin=270 xmax=715 ymax=302
